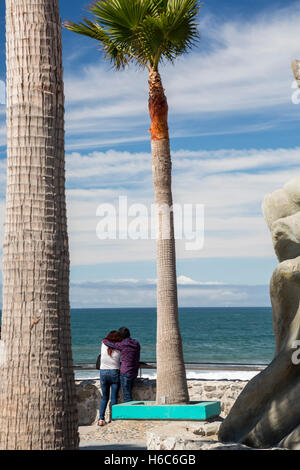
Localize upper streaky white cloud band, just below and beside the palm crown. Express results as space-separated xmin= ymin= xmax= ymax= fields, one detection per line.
xmin=62 ymin=5 xmax=300 ymax=149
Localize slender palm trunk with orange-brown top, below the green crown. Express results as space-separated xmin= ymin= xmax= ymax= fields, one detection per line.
xmin=149 ymin=70 xmax=189 ymax=404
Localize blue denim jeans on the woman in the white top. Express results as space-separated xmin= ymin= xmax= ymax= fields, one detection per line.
xmin=99 ymin=369 xmax=120 ymax=421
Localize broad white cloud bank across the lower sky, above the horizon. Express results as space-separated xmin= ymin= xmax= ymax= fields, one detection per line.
xmin=0 ymin=148 xmax=300 ymax=266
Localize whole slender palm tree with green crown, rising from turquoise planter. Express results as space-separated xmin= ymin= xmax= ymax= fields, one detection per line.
xmin=66 ymin=0 xmax=200 ymax=403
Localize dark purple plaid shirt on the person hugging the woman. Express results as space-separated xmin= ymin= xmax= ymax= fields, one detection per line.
xmin=103 ymin=338 xmax=141 ymax=378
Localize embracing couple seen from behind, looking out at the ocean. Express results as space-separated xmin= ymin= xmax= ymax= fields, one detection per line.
xmin=98 ymin=326 xmax=141 ymax=426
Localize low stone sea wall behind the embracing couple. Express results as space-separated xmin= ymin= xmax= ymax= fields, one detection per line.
xmin=76 ymin=378 xmax=247 ymax=426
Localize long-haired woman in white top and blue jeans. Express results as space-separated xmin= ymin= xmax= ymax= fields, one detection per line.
xmin=98 ymin=330 xmax=123 ymax=426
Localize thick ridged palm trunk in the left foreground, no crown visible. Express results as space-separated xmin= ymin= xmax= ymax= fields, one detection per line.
xmin=0 ymin=0 xmax=78 ymax=450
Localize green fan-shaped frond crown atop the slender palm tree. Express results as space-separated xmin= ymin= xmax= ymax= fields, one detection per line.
xmin=65 ymin=0 xmax=200 ymax=69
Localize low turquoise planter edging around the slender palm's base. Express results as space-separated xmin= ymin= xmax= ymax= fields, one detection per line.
xmin=112 ymin=401 xmax=221 ymax=421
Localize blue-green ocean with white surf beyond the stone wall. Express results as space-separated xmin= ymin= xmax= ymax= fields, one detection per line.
xmin=0 ymin=307 xmax=274 ymax=378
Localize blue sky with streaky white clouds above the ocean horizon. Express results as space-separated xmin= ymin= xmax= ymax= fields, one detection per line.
xmin=0 ymin=0 xmax=300 ymax=307
